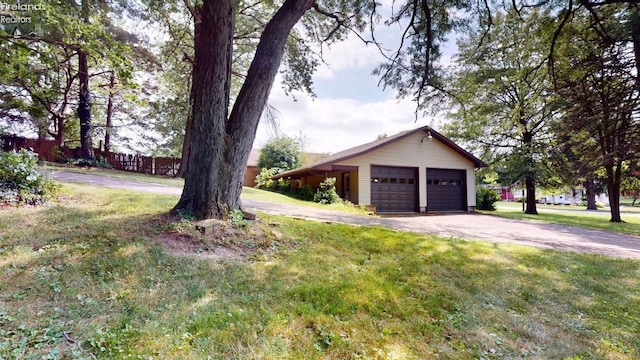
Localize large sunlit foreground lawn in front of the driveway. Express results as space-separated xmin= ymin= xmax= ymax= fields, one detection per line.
xmin=0 ymin=185 xmax=640 ymax=359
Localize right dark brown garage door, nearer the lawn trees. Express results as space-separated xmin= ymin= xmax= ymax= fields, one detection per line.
xmin=427 ymin=168 xmax=467 ymax=212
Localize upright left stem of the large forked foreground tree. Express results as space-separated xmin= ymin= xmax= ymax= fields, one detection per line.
xmin=173 ymin=0 xmax=236 ymax=219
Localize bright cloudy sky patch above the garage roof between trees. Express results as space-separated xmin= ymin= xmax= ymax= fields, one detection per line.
xmin=254 ymin=21 xmax=450 ymax=153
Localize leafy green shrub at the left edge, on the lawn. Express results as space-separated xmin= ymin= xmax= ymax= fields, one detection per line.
xmin=0 ymin=149 xmax=55 ymax=205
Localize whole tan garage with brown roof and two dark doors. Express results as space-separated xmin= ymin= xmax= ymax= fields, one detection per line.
xmin=274 ymin=126 xmax=486 ymax=213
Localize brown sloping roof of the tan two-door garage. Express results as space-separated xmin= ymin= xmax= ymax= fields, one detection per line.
xmin=273 ymin=126 xmax=487 ymax=179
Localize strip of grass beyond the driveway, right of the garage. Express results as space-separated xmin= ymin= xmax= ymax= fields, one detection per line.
xmin=478 ymin=202 xmax=640 ymax=236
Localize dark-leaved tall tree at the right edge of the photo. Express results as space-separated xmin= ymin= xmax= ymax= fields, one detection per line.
xmin=556 ymin=8 xmax=640 ymax=222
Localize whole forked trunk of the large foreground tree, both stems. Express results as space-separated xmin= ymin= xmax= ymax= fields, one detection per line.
xmin=173 ymin=0 xmax=314 ymax=219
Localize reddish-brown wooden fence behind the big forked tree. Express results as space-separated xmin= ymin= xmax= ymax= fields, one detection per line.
xmin=0 ymin=135 xmax=180 ymax=176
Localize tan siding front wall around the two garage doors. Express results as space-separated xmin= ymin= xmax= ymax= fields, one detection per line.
xmin=338 ymin=132 xmax=476 ymax=210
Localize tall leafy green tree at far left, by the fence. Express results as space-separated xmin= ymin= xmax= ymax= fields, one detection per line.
xmin=0 ymin=0 xmax=140 ymax=158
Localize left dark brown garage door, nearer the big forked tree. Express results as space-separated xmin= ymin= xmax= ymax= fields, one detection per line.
xmin=371 ymin=166 xmax=418 ymax=212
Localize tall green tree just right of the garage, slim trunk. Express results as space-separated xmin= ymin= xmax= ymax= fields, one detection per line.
xmin=445 ymin=9 xmax=557 ymax=214
